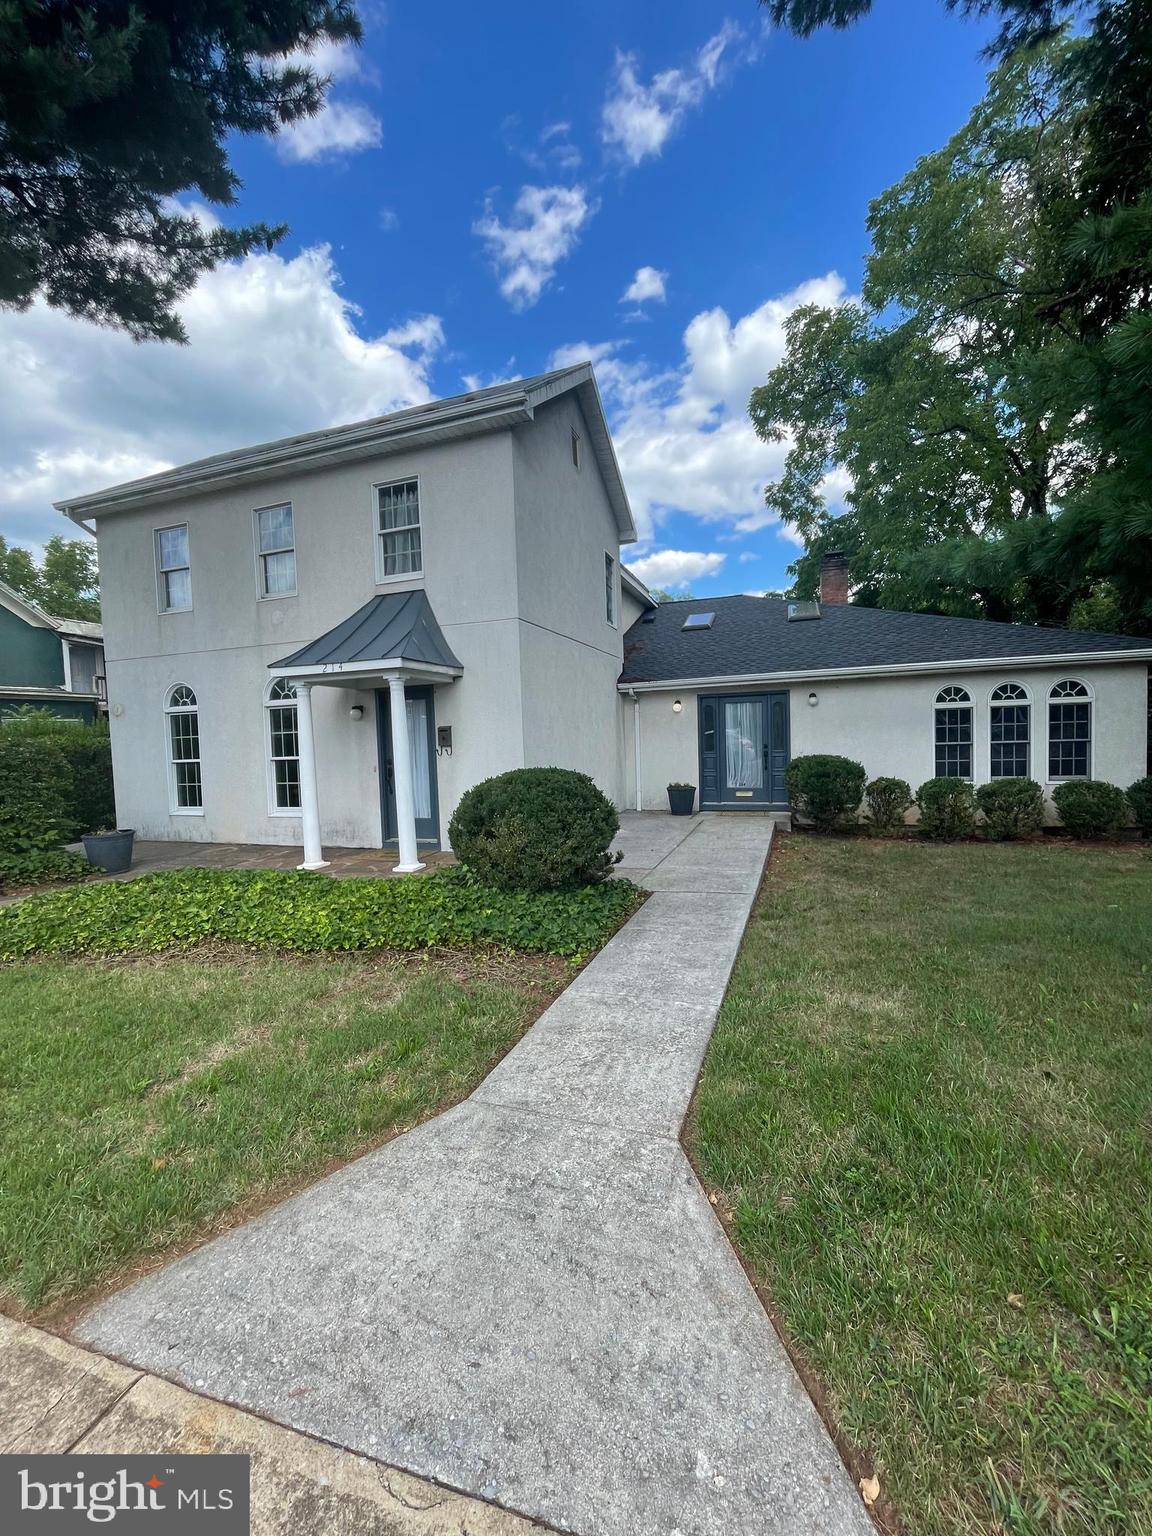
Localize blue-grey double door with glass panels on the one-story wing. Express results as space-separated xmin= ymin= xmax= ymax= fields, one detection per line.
xmin=699 ymin=693 xmax=788 ymax=811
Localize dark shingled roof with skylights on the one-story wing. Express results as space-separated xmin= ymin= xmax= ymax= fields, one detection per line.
xmin=621 ymin=598 xmax=1152 ymax=684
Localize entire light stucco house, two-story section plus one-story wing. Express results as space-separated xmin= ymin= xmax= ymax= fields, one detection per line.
xmin=60 ymin=364 xmax=1152 ymax=869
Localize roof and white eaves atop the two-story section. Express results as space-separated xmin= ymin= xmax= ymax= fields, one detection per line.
xmin=55 ymin=362 xmax=636 ymax=544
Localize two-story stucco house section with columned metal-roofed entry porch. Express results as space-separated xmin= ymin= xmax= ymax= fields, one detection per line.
xmin=61 ymin=364 xmax=636 ymax=868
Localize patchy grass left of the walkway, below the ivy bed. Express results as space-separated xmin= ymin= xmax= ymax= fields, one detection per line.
xmin=0 ymin=946 xmax=567 ymax=1310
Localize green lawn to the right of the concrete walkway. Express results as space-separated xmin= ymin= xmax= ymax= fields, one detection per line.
xmin=694 ymin=837 xmax=1152 ymax=1536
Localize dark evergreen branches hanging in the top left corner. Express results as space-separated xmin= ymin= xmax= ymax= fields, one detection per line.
xmin=0 ymin=0 xmax=361 ymax=341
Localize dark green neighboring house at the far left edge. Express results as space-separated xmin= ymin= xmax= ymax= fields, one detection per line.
xmin=0 ymin=582 xmax=104 ymax=720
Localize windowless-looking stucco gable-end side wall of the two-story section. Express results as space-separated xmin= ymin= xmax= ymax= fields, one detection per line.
xmin=513 ymin=395 xmax=624 ymax=803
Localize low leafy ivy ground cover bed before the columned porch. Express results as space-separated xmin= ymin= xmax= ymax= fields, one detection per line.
xmin=0 ymin=868 xmax=642 ymax=960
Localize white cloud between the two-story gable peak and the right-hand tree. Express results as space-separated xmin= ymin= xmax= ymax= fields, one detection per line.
xmin=550 ymin=272 xmax=846 ymax=541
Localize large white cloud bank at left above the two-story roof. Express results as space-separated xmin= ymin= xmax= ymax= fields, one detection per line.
xmin=0 ymin=246 xmax=444 ymax=544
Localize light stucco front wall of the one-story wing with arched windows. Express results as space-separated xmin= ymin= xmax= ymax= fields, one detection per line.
xmin=625 ymin=662 xmax=1147 ymax=811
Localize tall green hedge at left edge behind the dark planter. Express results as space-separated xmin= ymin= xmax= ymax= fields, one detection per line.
xmin=0 ymin=714 xmax=115 ymax=856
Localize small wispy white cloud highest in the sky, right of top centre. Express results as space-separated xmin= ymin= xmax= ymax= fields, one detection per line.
xmin=601 ymin=22 xmax=743 ymax=166
